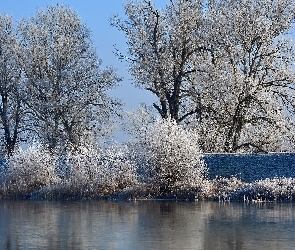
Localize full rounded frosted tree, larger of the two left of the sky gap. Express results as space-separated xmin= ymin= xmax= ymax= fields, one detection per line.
xmin=19 ymin=5 xmax=120 ymax=152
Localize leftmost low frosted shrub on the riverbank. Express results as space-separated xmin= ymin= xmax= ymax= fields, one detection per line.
xmin=1 ymin=145 xmax=59 ymax=196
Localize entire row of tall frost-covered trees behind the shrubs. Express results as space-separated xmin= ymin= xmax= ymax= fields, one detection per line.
xmin=0 ymin=0 xmax=295 ymax=155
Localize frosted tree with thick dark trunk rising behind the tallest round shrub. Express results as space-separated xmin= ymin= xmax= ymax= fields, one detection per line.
xmin=112 ymin=0 xmax=204 ymax=123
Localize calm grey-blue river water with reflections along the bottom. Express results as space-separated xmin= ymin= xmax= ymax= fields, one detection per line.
xmin=0 ymin=200 xmax=295 ymax=250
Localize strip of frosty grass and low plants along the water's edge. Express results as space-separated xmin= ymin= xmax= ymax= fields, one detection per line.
xmin=0 ymin=177 xmax=295 ymax=202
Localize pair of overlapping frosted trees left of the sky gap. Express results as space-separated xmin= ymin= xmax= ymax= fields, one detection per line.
xmin=0 ymin=5 xmax=121 ymax=154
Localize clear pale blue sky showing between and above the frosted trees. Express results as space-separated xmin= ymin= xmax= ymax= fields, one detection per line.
xmin=0 ymin=0 xmax=169 ymax=141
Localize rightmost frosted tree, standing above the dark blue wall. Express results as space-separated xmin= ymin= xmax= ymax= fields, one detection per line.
xmin=201 ymin=0 xmax=295 ymax=152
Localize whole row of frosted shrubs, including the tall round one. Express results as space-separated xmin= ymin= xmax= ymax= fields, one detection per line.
xmin=0 ymin=119 xmax=207 ymax=199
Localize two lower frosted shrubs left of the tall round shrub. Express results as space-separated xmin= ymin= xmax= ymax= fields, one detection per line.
xmin=0 ymin=145 xmax=137 ymax=199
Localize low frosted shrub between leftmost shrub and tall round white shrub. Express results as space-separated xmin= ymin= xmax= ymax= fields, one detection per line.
xmin=60 ymin=146 xmax=137 ymax=197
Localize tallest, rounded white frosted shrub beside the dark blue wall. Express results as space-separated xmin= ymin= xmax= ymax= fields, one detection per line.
xmin=139 ymin=119 xmax=207 ymax=193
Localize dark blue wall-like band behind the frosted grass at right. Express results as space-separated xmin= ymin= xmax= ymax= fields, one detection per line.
xmin=204 ymin=154 xmax=295 ymax=182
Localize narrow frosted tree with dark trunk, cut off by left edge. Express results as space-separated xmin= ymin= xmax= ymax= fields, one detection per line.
xmin=0 ymin=15 xmax=24 ymax=157
